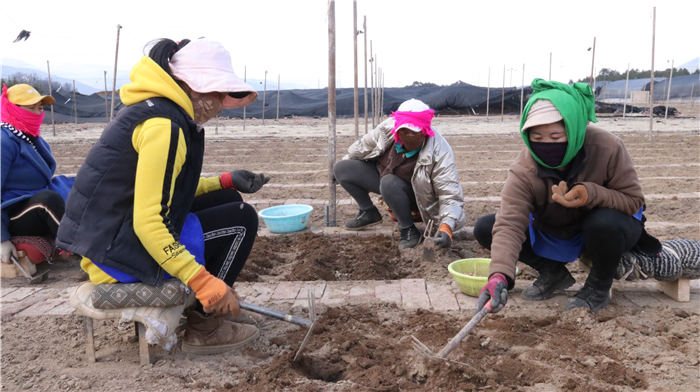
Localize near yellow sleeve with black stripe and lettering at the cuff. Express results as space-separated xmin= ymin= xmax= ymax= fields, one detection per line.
xmin=131 ymin=118 xmax=202 ymax=284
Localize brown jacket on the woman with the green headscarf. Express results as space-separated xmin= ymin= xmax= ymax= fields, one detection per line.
xmin=489 ymin=125 xmax=644 ymax=282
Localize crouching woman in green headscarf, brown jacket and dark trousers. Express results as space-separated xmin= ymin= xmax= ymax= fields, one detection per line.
xmin=474 ymin=79 xmax=661 ymax=312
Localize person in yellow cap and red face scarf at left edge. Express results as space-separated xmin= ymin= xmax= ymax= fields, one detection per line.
xmin=0 ymin=84 xmax=73 ymax=263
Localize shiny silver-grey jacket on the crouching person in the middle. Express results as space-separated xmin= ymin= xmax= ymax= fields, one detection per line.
xmin=343 ymin=117 xmax=467 ymax=231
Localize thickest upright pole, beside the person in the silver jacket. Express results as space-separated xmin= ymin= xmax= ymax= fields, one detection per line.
xmin=325 ymin=0 xmax=337 ymax=227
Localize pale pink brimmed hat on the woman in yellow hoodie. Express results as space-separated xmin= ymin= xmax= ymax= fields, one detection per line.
xmin=170 ymin=38 xmax=258 ymax=109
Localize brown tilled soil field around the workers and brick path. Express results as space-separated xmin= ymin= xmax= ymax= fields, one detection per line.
xmin=2 ymin=117 xmax=700 ymax=391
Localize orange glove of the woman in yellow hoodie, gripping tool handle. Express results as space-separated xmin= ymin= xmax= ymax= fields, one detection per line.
xmin=189 ymin=267 xmax=241 ymax=316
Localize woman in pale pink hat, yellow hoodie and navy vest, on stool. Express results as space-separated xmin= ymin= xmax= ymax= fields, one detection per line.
xmin=58 ymin=38 xmax=269 ymax=354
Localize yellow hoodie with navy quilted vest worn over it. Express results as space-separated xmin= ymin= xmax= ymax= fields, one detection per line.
xmin=57 ymin=57 xmax=221 ymax=285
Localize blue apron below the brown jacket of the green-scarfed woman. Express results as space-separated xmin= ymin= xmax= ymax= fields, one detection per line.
xmin=528 ymin=206 xmax=644 ymax=263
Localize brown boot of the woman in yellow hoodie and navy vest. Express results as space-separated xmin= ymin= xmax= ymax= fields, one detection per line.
xmin=182 ymin=311 xmax=260 ymax=354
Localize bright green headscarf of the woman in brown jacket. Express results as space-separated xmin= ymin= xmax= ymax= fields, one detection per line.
xmin=520 ymin=78 xmax=598 ymax=169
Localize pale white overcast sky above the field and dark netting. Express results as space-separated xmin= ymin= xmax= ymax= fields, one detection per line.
xmin=0 ymin=0 xmax=700 ymax=89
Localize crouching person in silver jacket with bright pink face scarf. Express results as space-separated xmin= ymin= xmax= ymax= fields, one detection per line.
xmin=333 ymin=99 xmax=466 ymax=249
